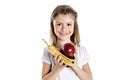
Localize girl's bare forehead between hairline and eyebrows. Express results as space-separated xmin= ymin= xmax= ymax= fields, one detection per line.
xmin=54 ymin=14 xmax=74 ymax=22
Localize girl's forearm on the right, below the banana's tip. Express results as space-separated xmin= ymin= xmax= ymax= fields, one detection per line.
xmin=72 ymin=66 xmax=92 ymax=80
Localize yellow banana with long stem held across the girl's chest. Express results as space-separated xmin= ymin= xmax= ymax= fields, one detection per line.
xmin=42 ymin=39 xmax=74 ymax=66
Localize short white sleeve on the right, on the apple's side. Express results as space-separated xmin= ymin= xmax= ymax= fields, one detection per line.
xmin=78 ymin=47 xmax=90 ymax=66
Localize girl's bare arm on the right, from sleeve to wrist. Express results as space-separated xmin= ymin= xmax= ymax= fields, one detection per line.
xmin=72 ymin=63 xmax=93 ymax=80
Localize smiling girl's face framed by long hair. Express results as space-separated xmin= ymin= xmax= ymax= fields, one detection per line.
xmin=53 ymin=14 xmax=74 ymax=41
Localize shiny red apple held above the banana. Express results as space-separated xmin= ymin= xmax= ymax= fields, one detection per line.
xmin=64 ymin=43 xmax=75 ymax=59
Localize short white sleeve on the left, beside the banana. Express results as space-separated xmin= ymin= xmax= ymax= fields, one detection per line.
xmin=42 ymin=47 xmax=51 ymax=64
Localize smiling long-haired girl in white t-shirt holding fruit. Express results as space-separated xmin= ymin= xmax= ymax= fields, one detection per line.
xmin=42 ymin=5 xmax=92 ymax=80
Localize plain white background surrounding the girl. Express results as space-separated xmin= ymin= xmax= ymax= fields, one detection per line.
xmin=0 ymin=0 xmax=120 ymax=80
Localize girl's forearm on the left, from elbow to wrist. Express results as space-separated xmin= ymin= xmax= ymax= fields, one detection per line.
xmin=42 ymin=68 xmax=61 ymax=80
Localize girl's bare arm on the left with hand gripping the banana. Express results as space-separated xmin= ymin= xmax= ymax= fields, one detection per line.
xmin=42 ymin=56 xmax=65 ymax=80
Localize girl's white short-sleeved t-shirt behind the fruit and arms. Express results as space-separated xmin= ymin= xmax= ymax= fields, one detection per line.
xmin=42 ymin=46 xmax=90 ymax=80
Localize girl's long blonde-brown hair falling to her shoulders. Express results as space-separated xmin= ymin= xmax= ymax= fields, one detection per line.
xmin=50 ymin=5 xmax=80 ymax=45
